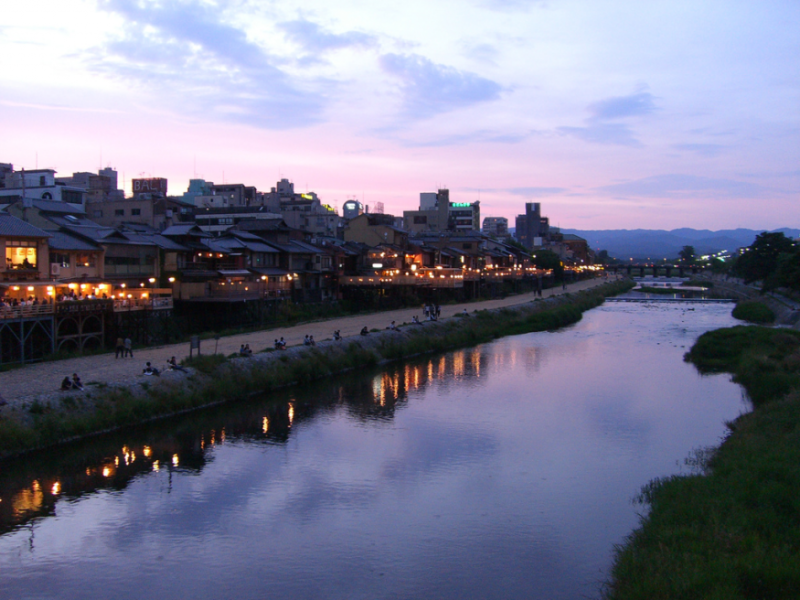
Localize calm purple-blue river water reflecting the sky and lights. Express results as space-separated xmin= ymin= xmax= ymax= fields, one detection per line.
xmin=0 ymin=303 xmax=748 ymax=599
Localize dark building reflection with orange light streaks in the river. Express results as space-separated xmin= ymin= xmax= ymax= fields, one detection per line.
xmin=0 ymin=349 xmax=485 ymax=533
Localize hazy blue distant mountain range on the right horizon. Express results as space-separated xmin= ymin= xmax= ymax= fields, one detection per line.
xmin=561 ymin=228 xmax=800 ymax=260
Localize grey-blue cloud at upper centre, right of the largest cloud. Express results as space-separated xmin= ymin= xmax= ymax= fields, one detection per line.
xmin=380 ymin=54 xmax=502 ymax=118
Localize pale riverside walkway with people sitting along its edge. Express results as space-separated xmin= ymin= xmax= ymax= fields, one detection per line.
xmin=0 ymin=278 xmax=613 ymax=408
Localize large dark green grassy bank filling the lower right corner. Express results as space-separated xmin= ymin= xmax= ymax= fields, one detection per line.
xmin=606 ymin=326 xmax=800 ymax=600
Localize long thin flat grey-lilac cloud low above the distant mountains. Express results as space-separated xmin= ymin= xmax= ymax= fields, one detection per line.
xmin=597 ymin=174 xmax=775 ymax=198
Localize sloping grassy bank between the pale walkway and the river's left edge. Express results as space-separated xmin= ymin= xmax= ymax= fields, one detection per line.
xmin=0 ymin=281 xmax=633 ymax=456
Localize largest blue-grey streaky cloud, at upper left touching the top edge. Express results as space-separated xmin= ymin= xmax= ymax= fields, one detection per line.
xmin=93 ymin=0 xmax=324 ymax=129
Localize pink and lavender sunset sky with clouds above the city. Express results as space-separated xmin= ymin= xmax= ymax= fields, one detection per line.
xmin=0 ymin=0 xmax=800 ymax=229
